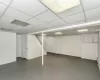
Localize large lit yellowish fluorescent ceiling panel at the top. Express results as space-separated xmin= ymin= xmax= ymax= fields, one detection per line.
xmin=41 ymin=0 xmax=80 ymax=13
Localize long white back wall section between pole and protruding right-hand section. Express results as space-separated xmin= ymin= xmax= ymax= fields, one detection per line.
xmin=46 ymin=35 xmax=81 ymax=57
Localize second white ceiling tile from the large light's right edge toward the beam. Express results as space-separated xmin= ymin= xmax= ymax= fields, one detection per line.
xmin=63 ymin=12 xmax=84 ymax=24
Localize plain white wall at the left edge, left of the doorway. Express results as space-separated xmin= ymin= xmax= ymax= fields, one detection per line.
xmin=0 ymin=32 xmax=16 ymax=65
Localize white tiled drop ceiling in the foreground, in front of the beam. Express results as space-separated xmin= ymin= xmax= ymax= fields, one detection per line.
xmin=0 ymin=0 xmax=100 ymax=33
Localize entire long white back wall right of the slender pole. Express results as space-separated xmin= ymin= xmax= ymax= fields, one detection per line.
xmin=38 ymin=33 xmax=98 ymax=60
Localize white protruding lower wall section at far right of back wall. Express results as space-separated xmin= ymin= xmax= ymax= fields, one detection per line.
xmin=81 ymin=43 xmax=98 ymax=60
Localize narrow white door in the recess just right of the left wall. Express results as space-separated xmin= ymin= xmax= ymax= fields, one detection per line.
xmin=16 ymin=34 xmax=27 ymax=58
